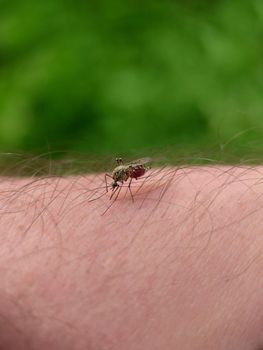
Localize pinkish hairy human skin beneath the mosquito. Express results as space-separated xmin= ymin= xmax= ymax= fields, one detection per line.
xmin=0 ymin=167 xmax=263 ymax=350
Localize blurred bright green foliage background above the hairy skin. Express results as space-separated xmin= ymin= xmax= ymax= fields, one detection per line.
xmin=0 ymin=0 xmax=263 ymax=165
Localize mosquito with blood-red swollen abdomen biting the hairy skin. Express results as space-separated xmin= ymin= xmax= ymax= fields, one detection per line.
xmin=105 ymin=157 xmax=151 ymax=201
